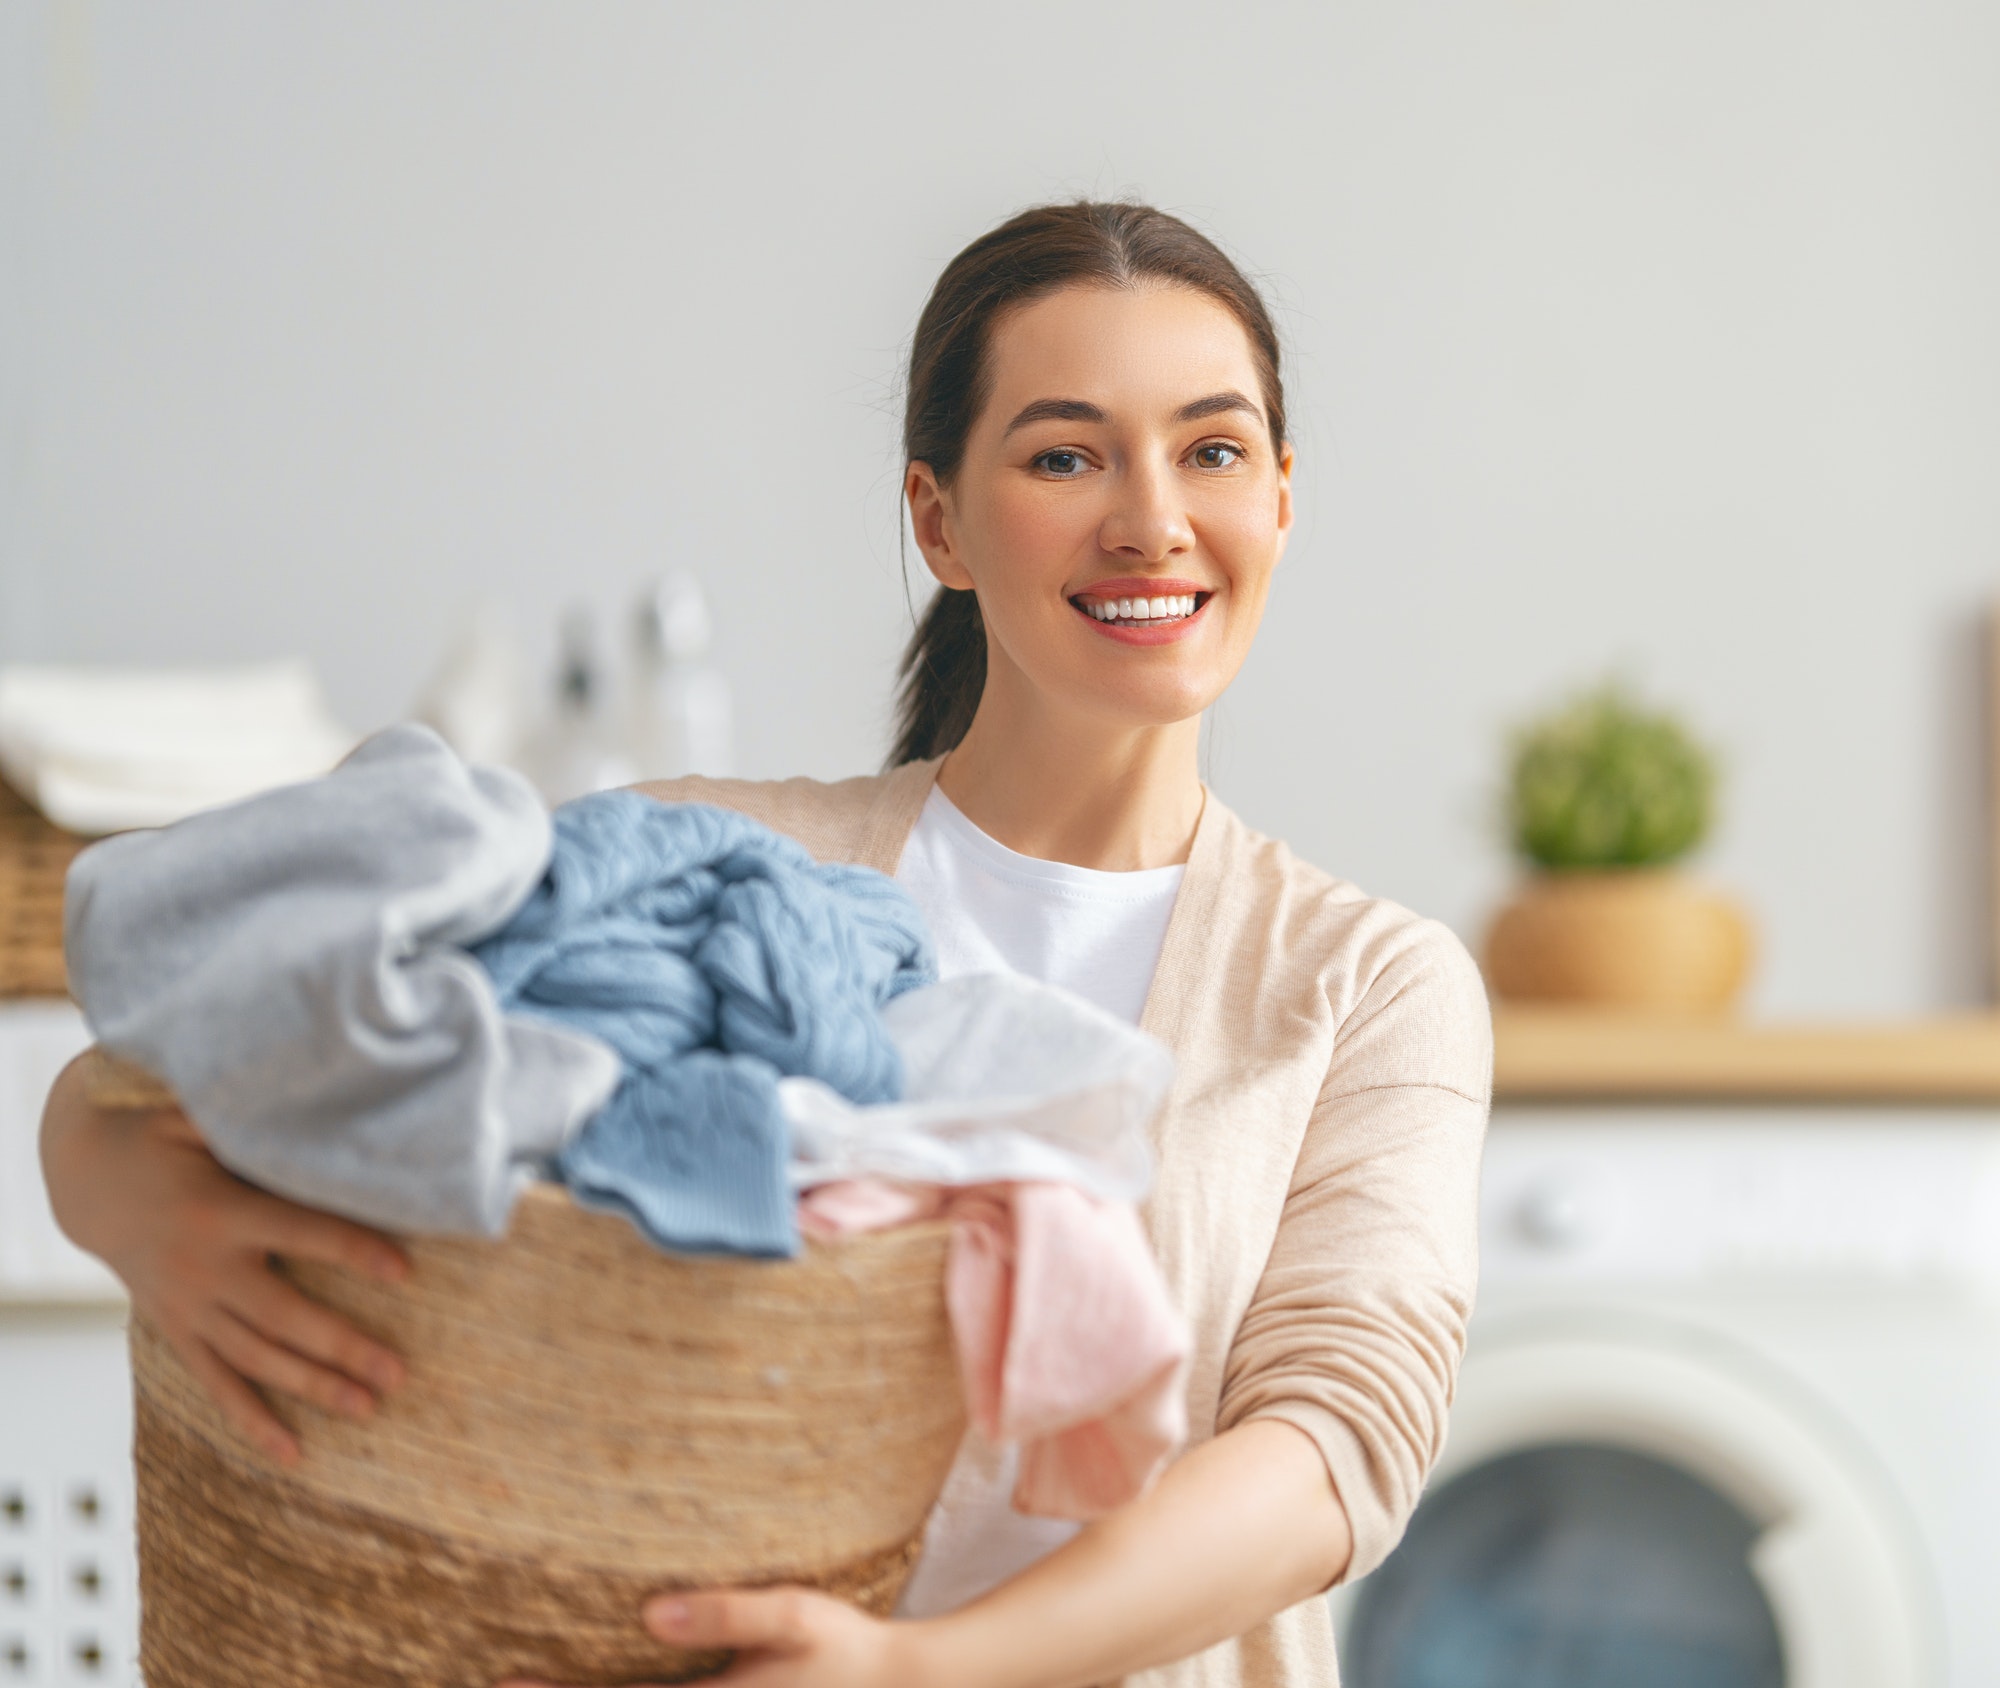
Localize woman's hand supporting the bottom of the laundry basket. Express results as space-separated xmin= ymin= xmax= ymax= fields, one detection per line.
xmin=502 ymin=1588 xmax=926 ymax=1688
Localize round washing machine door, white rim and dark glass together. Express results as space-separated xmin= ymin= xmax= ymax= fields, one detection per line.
xmin=1336 ymin=1326 xmax=1938 ymax=1688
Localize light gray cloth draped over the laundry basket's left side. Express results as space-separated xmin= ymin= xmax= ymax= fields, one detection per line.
xmin=66 ymin=726 xmax=620 ymax=1234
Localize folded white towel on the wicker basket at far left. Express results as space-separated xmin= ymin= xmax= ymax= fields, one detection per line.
xmin=0 ymin=662 xmax=354 ymax=834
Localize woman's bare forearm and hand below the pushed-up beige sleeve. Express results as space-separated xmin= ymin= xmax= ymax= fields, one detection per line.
xmin=512 ymin=1420 xmax=1348 ymax=1688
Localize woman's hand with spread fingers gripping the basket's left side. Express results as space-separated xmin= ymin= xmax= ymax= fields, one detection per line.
xmin=42 ymin=1062 xmax=410 ymax=1464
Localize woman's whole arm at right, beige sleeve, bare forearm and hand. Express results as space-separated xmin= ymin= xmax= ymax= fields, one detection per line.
xmin=508 ymin=936 xmax=1492 ymax=1688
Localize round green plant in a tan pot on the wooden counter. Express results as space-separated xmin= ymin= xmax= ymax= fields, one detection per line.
xmin=1486 ymin=684 xmax=1750 ymax=1012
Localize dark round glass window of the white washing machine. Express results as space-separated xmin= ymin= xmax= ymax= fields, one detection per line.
xmin=1344 ymin=1444 xmax=1784 ymax=1688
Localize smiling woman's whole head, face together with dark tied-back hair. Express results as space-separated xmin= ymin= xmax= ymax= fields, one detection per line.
xmin=896 ymin=204 xmax=1292 ymax=784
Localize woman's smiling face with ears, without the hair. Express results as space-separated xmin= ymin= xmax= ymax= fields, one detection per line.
xmin=906 ymin=284 xmax=1292 ymax=726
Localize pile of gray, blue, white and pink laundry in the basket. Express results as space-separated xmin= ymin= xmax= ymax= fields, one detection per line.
xmin=66 ymin=726 xmax=1188 ymax=1518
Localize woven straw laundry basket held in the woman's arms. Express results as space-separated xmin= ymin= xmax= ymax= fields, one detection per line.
xmin=92 ymin=1056 xmax=964 ymax=1688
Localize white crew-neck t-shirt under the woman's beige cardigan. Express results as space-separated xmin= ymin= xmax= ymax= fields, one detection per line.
xmin=896 ymin=786 xmax=1182 ymax=1618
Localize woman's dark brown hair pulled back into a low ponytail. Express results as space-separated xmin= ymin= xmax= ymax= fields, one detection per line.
xmin=890 ymin=200 xmax=1286 ymax=766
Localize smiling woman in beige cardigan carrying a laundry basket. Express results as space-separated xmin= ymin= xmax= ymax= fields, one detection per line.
xmin=44 ymin=204 xmax=1490 ymax=1688
